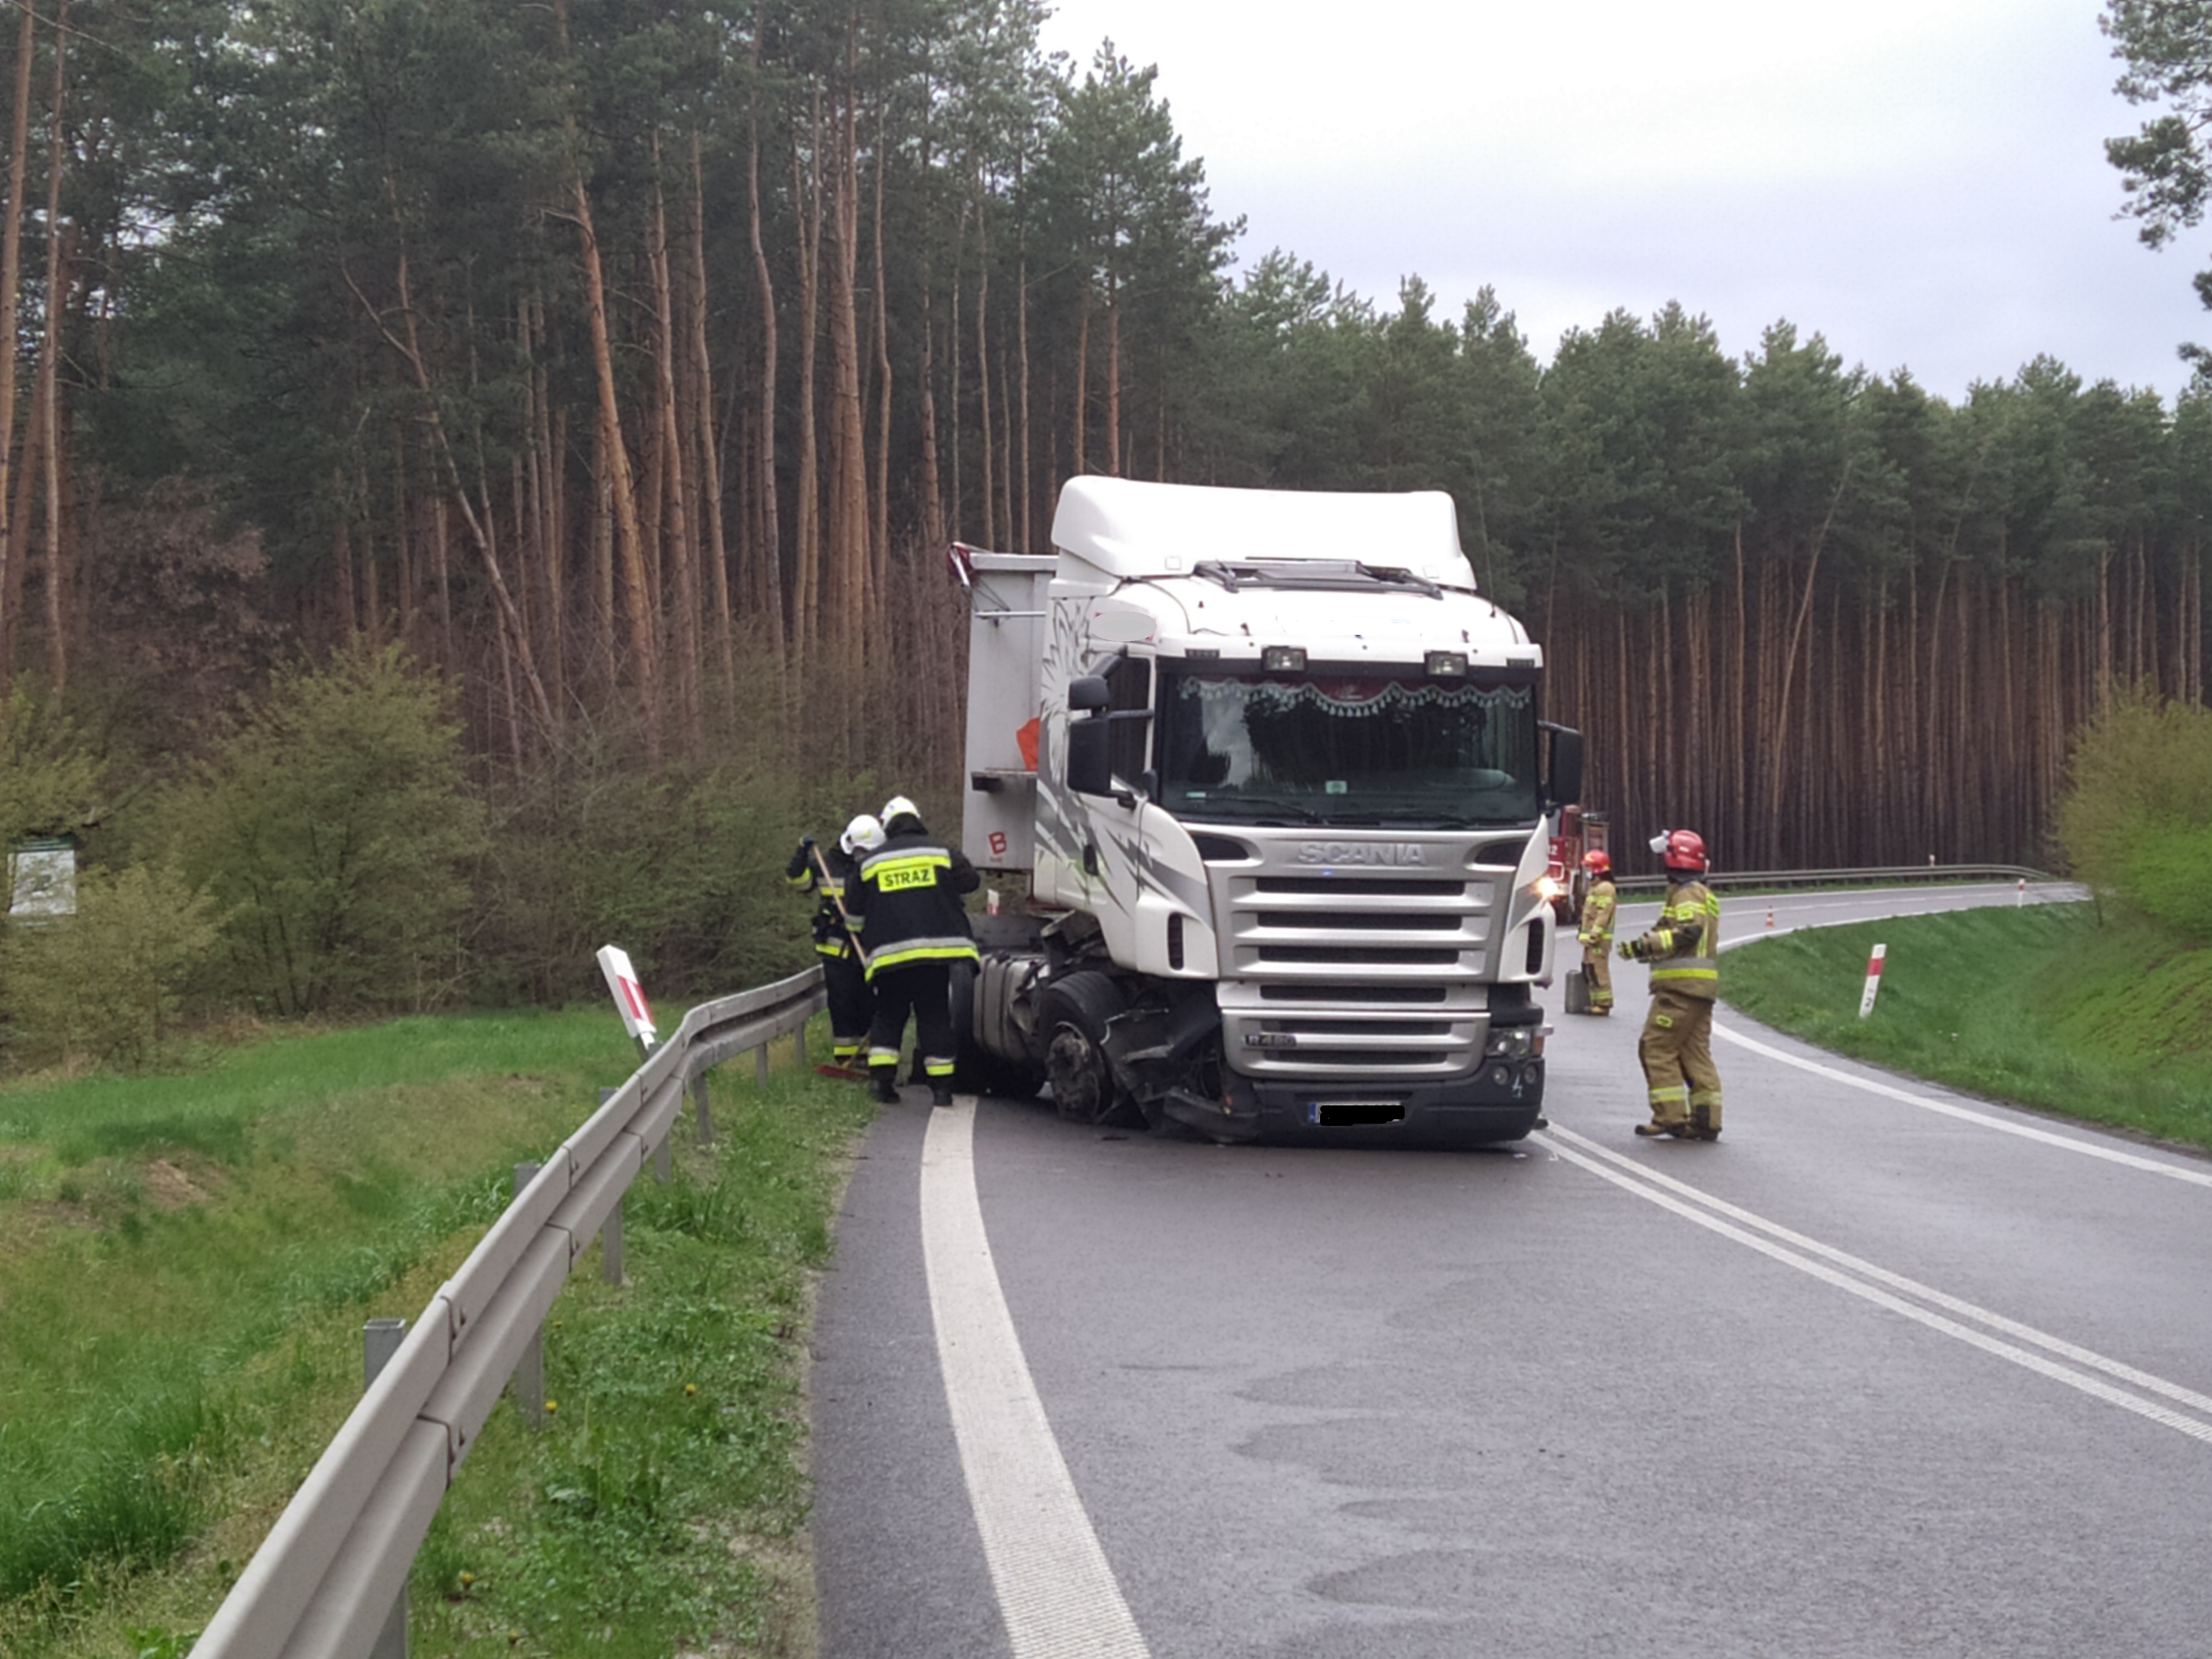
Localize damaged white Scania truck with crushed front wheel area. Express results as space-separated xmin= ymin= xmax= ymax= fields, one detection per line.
xmin=951 ymin=478 xmax=1582 ymax=1144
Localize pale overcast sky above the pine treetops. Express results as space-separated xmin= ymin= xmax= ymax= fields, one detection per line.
xmin=1046 ymin=0 xmax=2212 ymax=400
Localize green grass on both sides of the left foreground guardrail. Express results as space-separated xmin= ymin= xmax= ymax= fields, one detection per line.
xmin=0 ymin=1009 xmax=867 ymax=1659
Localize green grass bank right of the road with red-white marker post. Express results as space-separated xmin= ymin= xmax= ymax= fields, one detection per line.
xmin=1721 ymin=905 xmax=2212 ymax=1146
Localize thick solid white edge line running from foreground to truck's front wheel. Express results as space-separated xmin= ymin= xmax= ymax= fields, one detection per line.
xmin=922 ymin=1095 xmax=1150 ymax=1659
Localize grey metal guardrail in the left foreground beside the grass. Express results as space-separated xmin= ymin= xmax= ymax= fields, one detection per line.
xmin=192 ymin=967 xmax=825 ymax=1659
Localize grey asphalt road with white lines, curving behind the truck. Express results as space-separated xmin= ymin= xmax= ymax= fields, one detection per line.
xmin=812 ymin=887 xmax=2212 ymax=1659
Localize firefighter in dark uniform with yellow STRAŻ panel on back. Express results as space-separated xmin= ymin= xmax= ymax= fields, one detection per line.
xmin=845 ymin=794 xmax=982 ymax=1106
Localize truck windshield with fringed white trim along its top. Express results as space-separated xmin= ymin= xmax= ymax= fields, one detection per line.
xmin=1155 ymin=672 xmax=1540 ymax=825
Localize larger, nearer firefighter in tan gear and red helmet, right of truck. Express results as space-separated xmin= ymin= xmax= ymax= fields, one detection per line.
xmin=1621 ymin=830 xmax=1721 ymax=1141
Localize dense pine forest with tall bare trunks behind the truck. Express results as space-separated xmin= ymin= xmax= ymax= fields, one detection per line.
xmin=0 ymin=0 xmax=2212 ymax=980
